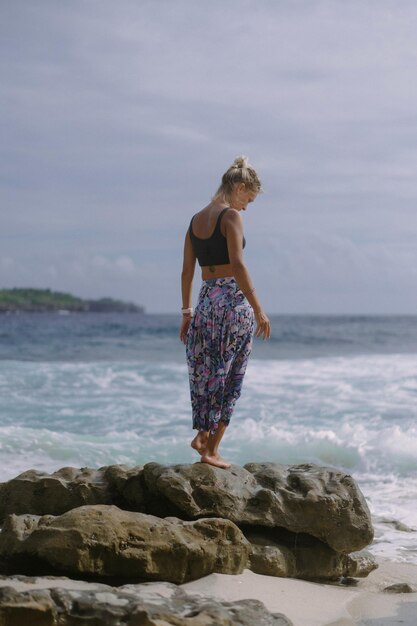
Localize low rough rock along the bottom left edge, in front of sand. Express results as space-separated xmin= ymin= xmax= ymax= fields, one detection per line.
xmin=0 ymin=577 xmax=292 ymax=626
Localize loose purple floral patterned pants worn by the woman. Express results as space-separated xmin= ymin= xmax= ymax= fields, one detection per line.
xmin=186 ymin=277 xmax=254 ymax=434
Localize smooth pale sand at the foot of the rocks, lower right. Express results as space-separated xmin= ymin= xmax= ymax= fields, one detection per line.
xmin=182 ymin=559 xmax=417 ymax=626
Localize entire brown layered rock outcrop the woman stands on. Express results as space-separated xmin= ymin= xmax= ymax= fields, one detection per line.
xmin=0 ymin=463 xmax=376 ymax=582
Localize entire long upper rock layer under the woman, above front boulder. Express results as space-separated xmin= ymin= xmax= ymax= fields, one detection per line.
xmin=0 ymin=463 xmax=373 ymax=553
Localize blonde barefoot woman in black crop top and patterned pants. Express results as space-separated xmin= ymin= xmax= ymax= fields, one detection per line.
xmin=180 ymin=156 xmax=271 ymax=468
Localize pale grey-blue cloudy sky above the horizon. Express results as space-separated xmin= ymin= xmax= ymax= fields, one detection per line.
xmin=0 ymin=0 xmax=417 ymax=314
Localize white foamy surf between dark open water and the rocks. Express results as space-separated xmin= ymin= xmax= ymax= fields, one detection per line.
xmin=0 ymin=354 xmax=417 ymax=563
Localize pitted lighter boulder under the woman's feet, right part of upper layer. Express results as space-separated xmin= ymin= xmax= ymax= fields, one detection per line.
xmin=143 ymin=463 xmax=373 ymax=553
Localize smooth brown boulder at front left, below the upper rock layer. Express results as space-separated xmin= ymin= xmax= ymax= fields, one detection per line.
xmin=0 ymin=505 xmax=250 ymax=583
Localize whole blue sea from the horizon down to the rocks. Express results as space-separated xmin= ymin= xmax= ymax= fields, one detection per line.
xmin=0 ymin=313 xmax=417 ymax=563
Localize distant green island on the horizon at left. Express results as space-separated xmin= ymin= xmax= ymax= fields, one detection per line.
xmin=0 ymin=288 xmax=145 ymax=313
